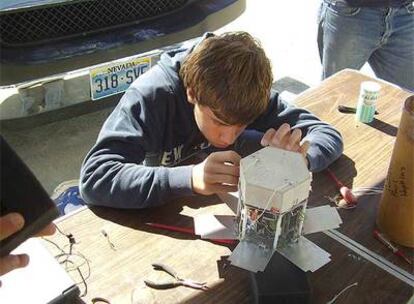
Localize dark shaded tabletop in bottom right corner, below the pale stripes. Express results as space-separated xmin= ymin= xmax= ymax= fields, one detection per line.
xmin=307 ymin=235 xmax=413 ymax=304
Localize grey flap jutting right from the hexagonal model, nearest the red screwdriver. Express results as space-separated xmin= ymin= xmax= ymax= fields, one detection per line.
xmin=303 ymin=205 xmax=342 ymax=235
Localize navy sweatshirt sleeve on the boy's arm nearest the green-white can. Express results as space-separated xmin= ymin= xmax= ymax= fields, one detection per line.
xmin=254 ymin=92 xmax=343 ymax=172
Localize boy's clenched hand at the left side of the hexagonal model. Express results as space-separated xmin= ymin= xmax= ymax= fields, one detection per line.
xmin=192 ymin=151 xmax=241 ymax=195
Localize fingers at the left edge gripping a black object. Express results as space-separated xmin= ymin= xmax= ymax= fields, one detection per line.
xmin=0 ymin=213 xmax=56 ymax=286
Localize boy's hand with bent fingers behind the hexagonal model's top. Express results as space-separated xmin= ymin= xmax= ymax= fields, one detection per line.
xmin=261 ymin=123 xmax=309 ymax=159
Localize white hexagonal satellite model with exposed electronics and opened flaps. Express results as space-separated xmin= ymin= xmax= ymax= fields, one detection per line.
xmin=194 ymin=147 xmax=342 ymax=272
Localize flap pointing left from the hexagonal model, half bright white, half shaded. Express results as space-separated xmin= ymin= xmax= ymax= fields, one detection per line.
xmin=194 ymin=214 xmax=237 ymax=240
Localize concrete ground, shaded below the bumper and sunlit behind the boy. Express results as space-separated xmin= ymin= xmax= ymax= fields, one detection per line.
xmin=1 ymin=0 xmax=376 ymax=194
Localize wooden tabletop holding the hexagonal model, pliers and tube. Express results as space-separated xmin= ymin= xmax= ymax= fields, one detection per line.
xmin=43 ymin=70 xmax=414 ymax=303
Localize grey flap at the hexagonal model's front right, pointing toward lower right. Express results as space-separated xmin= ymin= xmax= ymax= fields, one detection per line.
xmin=277 ymin=236 xmax=331 ymax=272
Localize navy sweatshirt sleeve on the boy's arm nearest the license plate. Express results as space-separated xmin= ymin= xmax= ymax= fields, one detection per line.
xmin=80 ymin=85 xmax=193 ymax=208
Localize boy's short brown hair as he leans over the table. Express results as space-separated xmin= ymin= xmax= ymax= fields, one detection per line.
xmin=180 ymin=32 xmax=272 ymax=125
